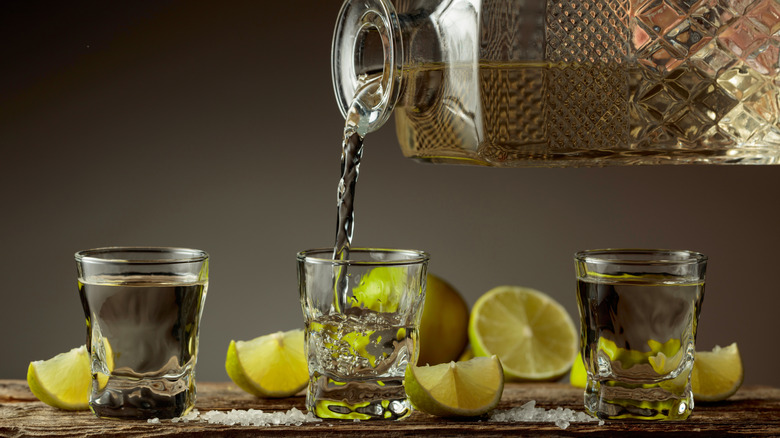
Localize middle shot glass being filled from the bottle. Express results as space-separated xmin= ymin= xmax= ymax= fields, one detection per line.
xmin=298 ymin=248 xmax=428 ymax=420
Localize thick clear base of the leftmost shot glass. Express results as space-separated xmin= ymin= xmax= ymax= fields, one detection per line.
xmin=89 ymin=376 xmax=195 ymax=419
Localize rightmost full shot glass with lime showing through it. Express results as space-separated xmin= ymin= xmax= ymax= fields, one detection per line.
xmin=575 ymin=249 xmax=707 ymax=420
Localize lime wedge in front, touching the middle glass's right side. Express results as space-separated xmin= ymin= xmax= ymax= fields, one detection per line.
xmin=404 ymin=356 xmax=504 ymax=417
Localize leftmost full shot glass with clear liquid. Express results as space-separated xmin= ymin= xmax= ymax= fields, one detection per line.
xmin=76 ymin=247 xmax=209 ymax=419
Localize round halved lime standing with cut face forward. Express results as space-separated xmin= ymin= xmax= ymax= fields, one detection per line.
xmin=469 ymin=286 xmax=579 ymax=380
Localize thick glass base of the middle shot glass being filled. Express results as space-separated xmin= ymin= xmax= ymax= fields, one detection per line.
xmin=306 ymin=374 xmax=412 ymax=420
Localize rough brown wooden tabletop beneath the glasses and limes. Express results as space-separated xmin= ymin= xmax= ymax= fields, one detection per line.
xmin=0 ymin=380 xmax=780 ymax=437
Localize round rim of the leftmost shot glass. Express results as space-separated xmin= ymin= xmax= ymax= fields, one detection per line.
xmin=75 ymin=246 xmax=209 ymax=265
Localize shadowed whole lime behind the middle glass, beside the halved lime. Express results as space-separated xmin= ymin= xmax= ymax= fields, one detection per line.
xmin=417 ymin=274 xmax=469 ymax=365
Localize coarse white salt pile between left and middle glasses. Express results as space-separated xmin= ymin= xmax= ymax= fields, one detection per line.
xmin=171 ymin=408 xmax=322 ymax=426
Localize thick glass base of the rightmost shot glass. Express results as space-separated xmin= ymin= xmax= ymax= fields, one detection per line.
xmin=585 ymin=380 xmax=693 ymax=420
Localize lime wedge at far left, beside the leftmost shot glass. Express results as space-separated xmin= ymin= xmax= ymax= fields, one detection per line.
xmin=27 ymin=345 xmax=92 ymax=411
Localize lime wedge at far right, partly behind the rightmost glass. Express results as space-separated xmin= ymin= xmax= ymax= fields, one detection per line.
xmin=691 ymin=342 xmax=744 ymax=402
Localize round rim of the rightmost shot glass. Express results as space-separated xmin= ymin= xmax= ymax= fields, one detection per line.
xmin=574 ymin=248 xmax=708 ymax=265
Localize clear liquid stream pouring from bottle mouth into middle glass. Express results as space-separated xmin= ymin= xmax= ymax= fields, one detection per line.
xmin=333 ymin=76 xmax=381 ymax=311
